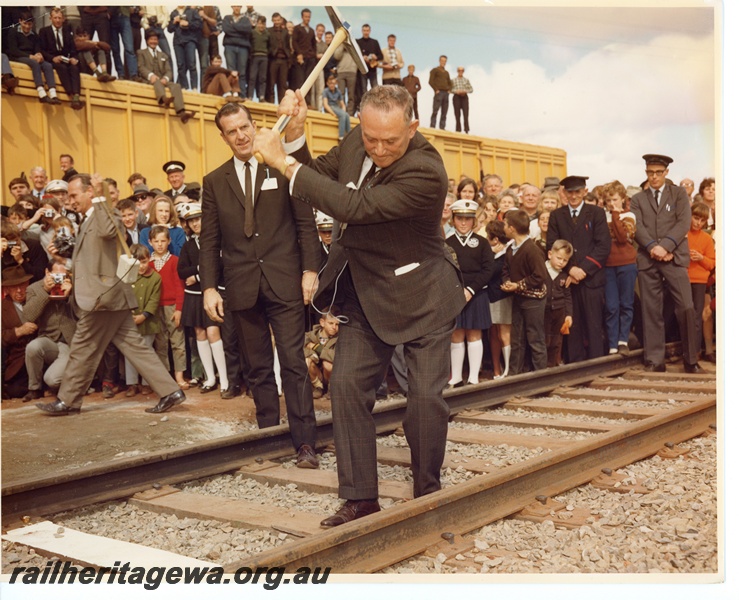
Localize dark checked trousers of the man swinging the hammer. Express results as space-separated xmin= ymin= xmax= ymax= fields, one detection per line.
xmin=331 ymin=278 xmax=454 ymax=500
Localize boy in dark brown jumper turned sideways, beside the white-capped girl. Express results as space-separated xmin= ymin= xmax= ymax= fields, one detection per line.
xmin=500 ymin=210 xmax=549 ymax=375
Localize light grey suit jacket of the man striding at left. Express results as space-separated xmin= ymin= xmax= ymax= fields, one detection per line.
xmin=72 ymin=202 xmax=138 ymax=312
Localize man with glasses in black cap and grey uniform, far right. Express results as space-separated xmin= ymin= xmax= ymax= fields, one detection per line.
xmin=631 ymin=154 xmax=703 ymax=373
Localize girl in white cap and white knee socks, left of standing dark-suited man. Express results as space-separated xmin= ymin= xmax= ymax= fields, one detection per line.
xmin=177 ymin=202 xmax=229 ymax=396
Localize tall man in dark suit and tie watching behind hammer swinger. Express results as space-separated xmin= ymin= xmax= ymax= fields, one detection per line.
xmin=200 ymin=103 xmax=321 ymax=469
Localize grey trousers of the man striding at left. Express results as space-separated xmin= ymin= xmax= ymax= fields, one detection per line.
xmin=57 ymin=310 xmax=180 ymax=407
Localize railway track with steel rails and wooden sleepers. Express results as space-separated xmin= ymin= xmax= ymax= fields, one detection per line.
xmin=2 ymin=353 xmax=716 ymax=573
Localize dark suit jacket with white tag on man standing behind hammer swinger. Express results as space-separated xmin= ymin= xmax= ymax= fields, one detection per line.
xmin=200 ymin=158 xmax=321 ymax=310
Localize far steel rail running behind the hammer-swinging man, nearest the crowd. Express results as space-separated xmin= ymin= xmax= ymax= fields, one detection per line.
xmin=2 ymin=346 xmax=674 ymax=524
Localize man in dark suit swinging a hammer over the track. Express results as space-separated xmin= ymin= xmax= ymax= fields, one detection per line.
xmin=257 ymin=85 xmax=465 ymax=527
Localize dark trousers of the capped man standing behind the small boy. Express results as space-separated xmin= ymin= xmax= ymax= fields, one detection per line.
xmin=567 ymin=281 xmax=605 ymax=363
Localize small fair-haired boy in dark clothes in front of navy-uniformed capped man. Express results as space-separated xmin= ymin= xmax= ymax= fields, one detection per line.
xmin=544 ymin=240 xmax=575 ymax=367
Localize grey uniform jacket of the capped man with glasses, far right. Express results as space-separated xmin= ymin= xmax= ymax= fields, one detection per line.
xmin=631 ymin=184 xmax=690 ymax=270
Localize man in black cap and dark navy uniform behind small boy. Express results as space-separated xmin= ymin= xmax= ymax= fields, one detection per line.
xmin=547 ymin=175 xmax=611 ymax=363
